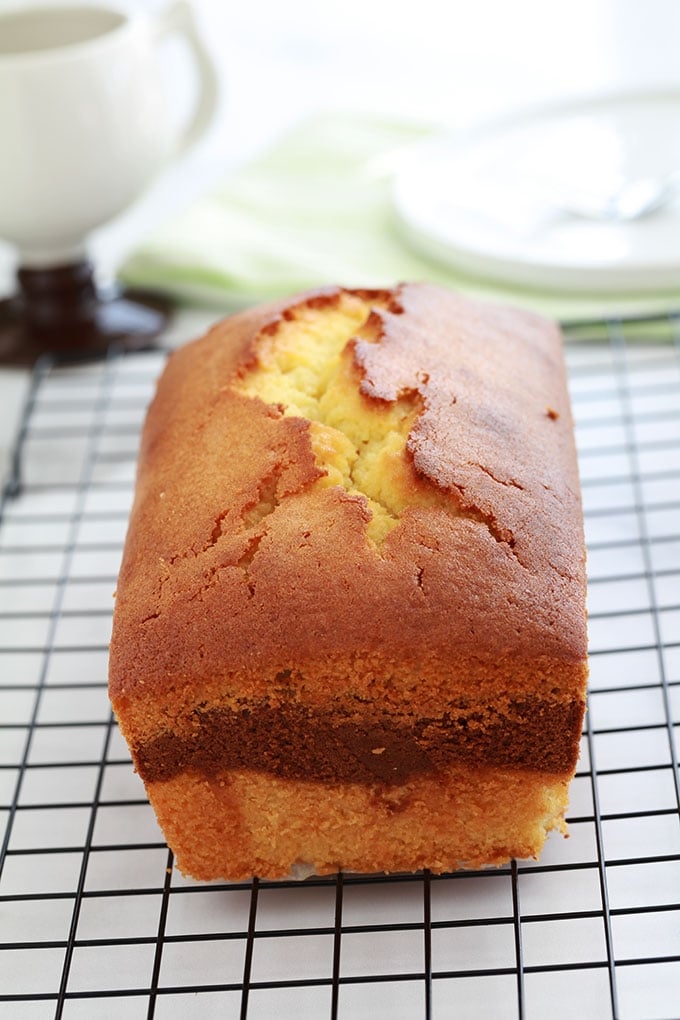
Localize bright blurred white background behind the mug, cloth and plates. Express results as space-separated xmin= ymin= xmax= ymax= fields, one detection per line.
xmin=0 ymin=0 xmax=680 ymax=461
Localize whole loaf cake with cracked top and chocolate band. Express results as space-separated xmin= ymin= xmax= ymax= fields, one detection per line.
xmin=110 ymin=284 xmax=586 ymax=879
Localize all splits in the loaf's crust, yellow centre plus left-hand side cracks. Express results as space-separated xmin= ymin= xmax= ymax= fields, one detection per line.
xmin=145 ymin=292 xmax=524 ymax=622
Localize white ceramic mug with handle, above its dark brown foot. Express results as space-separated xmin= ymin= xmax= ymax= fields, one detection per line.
xmin=0 ymin=0 xmax=217 ymax=268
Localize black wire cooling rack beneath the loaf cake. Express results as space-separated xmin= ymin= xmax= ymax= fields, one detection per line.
xmin=0 ymin=317 xmax=680 ymax=1020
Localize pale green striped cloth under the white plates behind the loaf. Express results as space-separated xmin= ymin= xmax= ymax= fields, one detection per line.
xmin=121 ymin=114 xmax=680 ymax=320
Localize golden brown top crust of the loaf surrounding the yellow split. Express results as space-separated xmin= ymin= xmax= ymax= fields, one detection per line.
xmin=111 ymin=285 xmax=585 ymax=699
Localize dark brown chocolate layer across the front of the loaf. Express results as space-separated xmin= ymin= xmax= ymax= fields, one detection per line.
xmin=135 ymin=699 xmax=583 ymax=784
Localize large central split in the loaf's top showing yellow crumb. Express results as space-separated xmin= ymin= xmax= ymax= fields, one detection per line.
xmin=231 ymin=292 xmax=523 ymax=561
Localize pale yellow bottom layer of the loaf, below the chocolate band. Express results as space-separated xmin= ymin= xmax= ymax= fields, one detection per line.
xmin=147 ymin=765 xmax=570 ymax=880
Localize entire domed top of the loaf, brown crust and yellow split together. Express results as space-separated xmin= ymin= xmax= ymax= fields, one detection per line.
xmin=111 ymin=285 xmax=585 ymax=722
